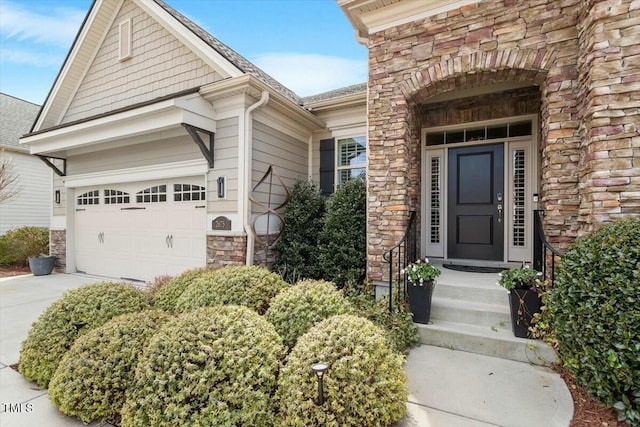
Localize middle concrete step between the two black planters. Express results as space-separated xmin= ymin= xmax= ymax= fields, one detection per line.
xmin=431 ymin=298 xmax=511 ymax=328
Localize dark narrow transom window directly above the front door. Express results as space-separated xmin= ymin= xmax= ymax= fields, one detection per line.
xmin=426 ymin=120 xmax=532 ymax=145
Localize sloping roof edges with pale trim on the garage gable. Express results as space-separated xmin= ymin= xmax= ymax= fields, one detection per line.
xmin=30 ymin=0 xmax=301 ymax=132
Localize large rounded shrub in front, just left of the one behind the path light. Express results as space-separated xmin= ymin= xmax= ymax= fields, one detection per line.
xmin=122 ymin=306 xmax=285 ymax=427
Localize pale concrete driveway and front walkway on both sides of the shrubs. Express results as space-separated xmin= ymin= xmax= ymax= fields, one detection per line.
xmin=0 ymin=274 xmax=573 ymax=427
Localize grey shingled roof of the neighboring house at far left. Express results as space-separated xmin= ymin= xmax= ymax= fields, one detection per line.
xmin=0 ymin=93 xmax=40 ymax=151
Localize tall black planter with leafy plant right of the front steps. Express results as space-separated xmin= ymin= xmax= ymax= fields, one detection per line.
xmin=498 ymin=263 xmax=545 ymax=338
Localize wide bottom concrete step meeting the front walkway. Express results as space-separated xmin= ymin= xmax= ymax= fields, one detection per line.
xmin=417 ymin=319 xmax=557 ymax=366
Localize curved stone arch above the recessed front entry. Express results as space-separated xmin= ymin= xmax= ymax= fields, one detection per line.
xmin=400 ymin=48 xmax=555 ymax=105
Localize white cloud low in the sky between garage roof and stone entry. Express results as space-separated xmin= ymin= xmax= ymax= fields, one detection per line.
xmin=251 ymin=53 xmax=367 ymax=96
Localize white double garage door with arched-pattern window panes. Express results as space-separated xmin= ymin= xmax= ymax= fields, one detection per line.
xmin=74 ymin=178 xmax=207 ymax=281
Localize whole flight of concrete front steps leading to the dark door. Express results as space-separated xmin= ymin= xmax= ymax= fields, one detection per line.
xmin=417 ymin=269 xmax=557 ymax=365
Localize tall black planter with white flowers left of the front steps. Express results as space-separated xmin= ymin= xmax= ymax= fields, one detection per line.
xmin=400 ymin=258 xmax=440 ymax=324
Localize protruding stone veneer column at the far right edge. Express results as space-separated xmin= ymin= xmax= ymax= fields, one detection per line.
xmin=578 ymin=0 xmax=640 ymax=231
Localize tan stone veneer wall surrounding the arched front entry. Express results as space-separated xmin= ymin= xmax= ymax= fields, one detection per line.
xmin=367 ymin=0 xmax=640 ymax=280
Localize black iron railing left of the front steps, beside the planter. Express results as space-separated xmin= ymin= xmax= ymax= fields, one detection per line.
xmin=382 ymin=211 xmax=418 ymax=312
